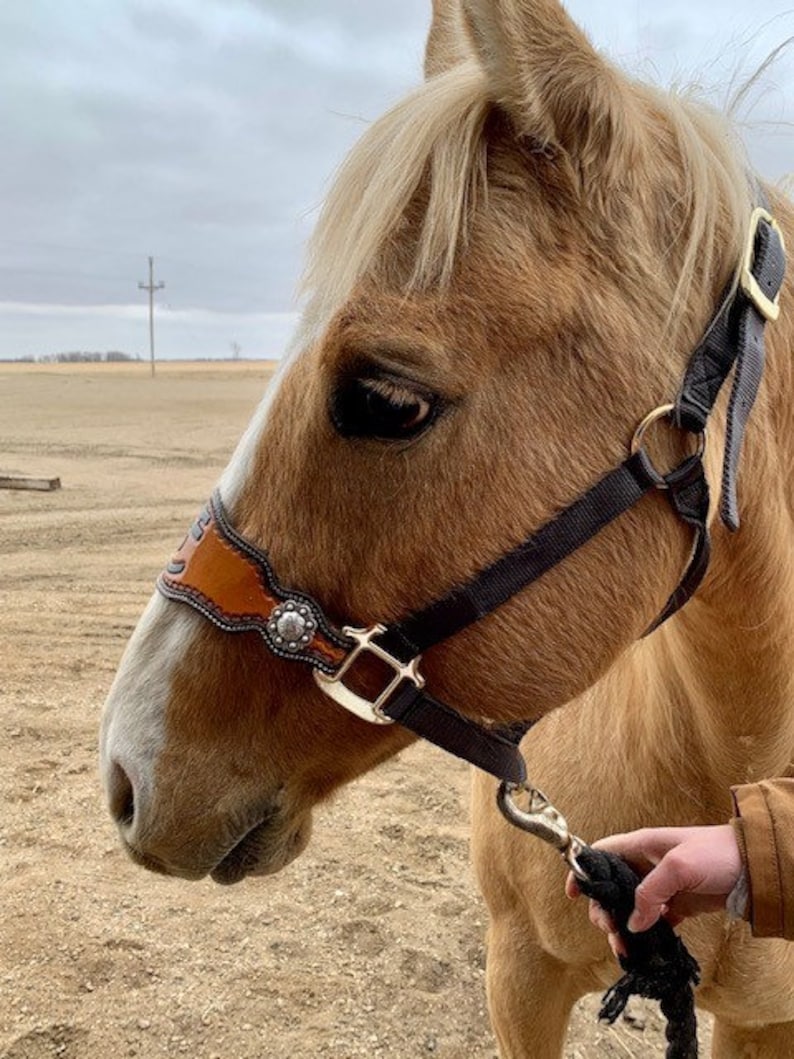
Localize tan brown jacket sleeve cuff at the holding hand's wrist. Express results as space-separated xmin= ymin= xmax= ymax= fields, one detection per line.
xmin=732 ymin=779 xmax=794 ymax=941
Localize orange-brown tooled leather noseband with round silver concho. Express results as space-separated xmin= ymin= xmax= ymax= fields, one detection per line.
xmin=158 ymin=506 xmax=347 ymax=669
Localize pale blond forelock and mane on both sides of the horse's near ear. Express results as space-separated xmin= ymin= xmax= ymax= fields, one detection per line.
xmin=302 ymin=59 xmax=755 ymax=340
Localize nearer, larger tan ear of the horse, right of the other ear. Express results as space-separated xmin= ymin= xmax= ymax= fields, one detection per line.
xmin=461 ymin=0 xmax=635 ymax=185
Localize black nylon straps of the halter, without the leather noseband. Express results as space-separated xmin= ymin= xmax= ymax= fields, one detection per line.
xmin=378 ymin=209 xmax=786 ymax=783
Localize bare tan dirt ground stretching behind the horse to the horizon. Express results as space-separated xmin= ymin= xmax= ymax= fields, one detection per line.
xmin=0 ymin=363 xmax=711 ymax=1059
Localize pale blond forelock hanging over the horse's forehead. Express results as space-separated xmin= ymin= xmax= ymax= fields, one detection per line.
xmin=303 ymin=59 xmax=492 ymax=317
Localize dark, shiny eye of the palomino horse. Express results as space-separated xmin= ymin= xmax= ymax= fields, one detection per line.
xmin=331 ymin=377 xmax=439 ymax=441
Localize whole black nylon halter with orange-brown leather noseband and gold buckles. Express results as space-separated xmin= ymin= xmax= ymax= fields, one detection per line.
xmin=158 ymin=208 xmax=786 ymax=785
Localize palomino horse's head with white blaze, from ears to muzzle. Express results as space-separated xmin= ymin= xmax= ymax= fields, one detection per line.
xmin=102 ymin=0 xmax=779 ymax=882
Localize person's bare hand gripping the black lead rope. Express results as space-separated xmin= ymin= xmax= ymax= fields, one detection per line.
xmin=565 ymin=824 xmax=742 ymax=955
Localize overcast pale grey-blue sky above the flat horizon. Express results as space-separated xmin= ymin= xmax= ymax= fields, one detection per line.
xmin=0 ymin=0 xmax=794 ymax=358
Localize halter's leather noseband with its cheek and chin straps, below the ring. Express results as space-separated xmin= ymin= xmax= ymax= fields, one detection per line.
xmin=157 ymin=450 xmax=673 ymax=786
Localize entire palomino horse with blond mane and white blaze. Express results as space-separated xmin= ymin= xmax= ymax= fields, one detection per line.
xmin=102 ymin=0 xmax=794 ymax=1059
